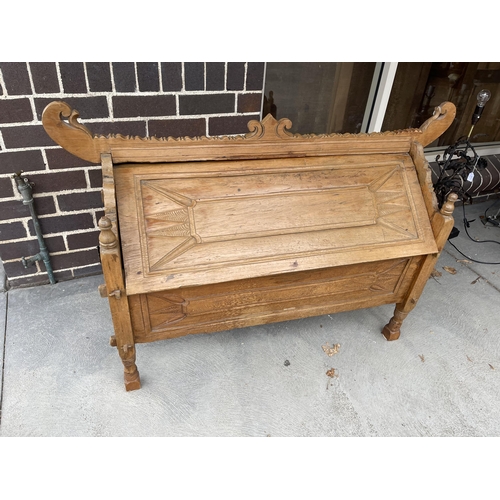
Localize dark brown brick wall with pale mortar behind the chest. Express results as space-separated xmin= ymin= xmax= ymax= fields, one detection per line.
xmin=0 ymin=62 xmax=264 ymax=287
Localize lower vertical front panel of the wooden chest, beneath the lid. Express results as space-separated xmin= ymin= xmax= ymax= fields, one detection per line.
xmin=128 ymin=257 xmax=422 ymax=342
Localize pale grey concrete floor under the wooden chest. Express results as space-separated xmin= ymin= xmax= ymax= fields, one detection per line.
xmin=0 ymin=203 xmax=500 ymax=437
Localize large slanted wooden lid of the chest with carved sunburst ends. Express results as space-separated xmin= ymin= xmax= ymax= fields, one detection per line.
xmin=115 ymin=155 xmax=437 ymax=294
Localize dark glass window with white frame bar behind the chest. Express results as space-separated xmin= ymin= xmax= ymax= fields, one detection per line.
xmin=263 ymin=62 xmax=500 ymax=154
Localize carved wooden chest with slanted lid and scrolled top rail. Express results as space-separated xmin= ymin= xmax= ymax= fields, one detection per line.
xmin=43 ymin=101 xmax=456 ymax=390
